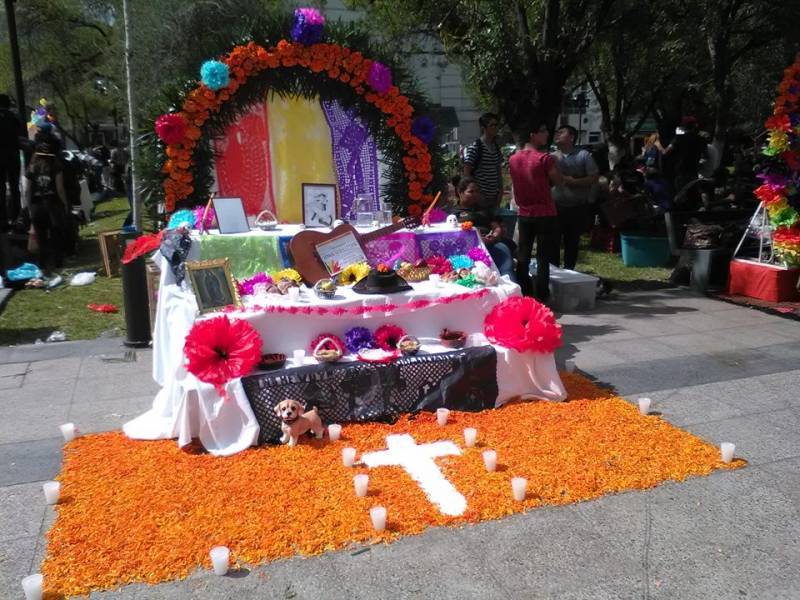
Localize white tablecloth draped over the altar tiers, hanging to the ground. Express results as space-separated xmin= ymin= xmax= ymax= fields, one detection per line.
xmin=123 ymin=231 xmax=566 ymax=455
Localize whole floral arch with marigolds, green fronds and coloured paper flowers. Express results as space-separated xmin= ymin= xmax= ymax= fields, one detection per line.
xmin=145 ymin=9 xmax=442 ymax=216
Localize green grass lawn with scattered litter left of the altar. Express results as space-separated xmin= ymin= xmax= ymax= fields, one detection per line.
xmin=0 ymin=197 xmax=128 ymax=345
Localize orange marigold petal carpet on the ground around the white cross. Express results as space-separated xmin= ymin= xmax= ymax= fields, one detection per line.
xmin=42 ymin=373 xmax=745 ymax=596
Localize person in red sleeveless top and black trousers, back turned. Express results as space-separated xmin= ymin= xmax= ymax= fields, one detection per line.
xmin=509 ymin=122 xmax=564 ymax=302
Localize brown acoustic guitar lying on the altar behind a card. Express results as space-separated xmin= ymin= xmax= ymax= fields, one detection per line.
xmin=289 ymin=217 xmax=420 ymax=285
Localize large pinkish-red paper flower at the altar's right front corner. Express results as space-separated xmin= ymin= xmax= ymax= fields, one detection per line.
xmin=483 ymin=297 xmax=561 ymax=354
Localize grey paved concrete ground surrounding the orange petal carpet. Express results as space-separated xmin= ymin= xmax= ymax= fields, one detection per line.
xmin=0 ymin=290 xmax=800 ymax=600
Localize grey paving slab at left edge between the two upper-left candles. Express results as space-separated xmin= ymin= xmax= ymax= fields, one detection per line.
xmin=0 ymin=436 xmax=64 ymax=488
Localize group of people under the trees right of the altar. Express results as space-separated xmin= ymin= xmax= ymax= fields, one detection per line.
xmin=452 ymin=113 xmax=753 ymax=301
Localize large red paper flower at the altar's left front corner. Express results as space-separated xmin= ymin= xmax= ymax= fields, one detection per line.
xmin=183 ymin=316 xmax=261 ymax=397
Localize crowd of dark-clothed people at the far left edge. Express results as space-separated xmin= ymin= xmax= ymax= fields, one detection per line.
xmin=0 ymin=94 xmax=129 ymax=276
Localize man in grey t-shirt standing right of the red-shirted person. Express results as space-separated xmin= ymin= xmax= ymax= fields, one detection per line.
xmin=553 ymin=125 xmax=598 ymax=269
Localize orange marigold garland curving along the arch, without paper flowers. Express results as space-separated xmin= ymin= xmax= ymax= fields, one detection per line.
xmin=161 ymin=40 xmax=433 ymax=216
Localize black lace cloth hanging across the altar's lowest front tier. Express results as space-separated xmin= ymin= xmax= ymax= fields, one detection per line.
xmin=242 ymin=346 xmax=497 ymax=444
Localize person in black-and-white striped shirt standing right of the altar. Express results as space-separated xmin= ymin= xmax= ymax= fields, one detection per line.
xmin=464 ymin=113 xmax=503 ymax=217
